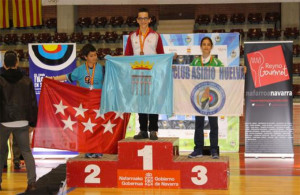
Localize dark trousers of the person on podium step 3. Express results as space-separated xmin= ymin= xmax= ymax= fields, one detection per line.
xmin=194 ymin=116 xmax=219 ymax=152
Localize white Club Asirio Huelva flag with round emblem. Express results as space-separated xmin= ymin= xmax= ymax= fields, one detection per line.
xmin=173 ymin=66 xmax=245 ymax=116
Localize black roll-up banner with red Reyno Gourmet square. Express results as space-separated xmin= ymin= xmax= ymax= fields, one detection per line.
xmin=245 ymin=41 xmax=294 ymax=157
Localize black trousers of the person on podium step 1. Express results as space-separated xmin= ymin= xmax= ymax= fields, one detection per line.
xmin=139 ymin=113 xmax=158 ymax=131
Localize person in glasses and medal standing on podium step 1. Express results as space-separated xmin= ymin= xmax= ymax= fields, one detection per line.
xmin=125 ymin=8 xmax=164 ymax=140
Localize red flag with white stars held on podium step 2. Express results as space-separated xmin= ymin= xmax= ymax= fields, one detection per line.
xmin=33 ymin=78 xmax=129 ymax=154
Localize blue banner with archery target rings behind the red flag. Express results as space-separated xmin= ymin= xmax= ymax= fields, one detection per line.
xmin=28 ymin=43 xmax=76 ymax=100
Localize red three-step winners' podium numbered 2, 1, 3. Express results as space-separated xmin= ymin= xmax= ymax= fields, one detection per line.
xmin=67 ymin=138 xmax=229 ymax=189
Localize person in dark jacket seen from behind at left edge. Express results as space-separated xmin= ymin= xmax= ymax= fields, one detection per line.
xmin=0 ymin=51 xmax=37 ymax=192
